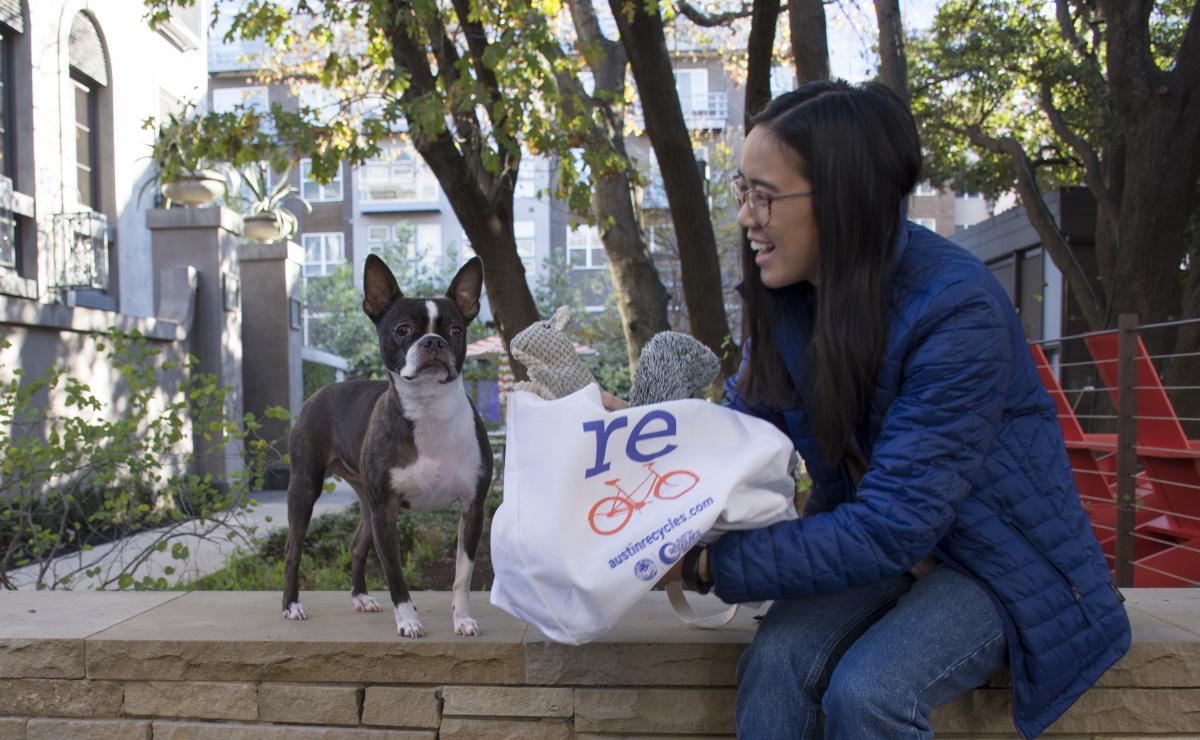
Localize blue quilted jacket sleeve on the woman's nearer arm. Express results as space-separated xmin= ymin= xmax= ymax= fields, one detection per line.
xmin=709 ymin=282 xmax=1013 ymax=603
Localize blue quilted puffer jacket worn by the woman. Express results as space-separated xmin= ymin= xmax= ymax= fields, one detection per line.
xmin=710 ymin=222 xmax=1130 ymax=738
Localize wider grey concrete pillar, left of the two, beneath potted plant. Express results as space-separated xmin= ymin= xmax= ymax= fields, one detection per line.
xmin=146 ymin=207 xmax=244 ymax=483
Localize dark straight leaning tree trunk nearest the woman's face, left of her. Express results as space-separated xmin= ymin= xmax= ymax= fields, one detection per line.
xmin=608 ymin=0 xmax=738 ymax=375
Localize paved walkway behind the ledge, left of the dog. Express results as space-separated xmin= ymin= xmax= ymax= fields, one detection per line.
xmin=11 ymin=481 xmax=356 ymax=590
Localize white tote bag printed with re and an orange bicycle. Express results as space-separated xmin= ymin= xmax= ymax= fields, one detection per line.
xmin=491 ymin=384 xmax=796 ymax=645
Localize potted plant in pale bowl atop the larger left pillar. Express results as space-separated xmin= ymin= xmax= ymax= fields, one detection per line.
xmin=143 ymin=103 xmax=226 ymax=206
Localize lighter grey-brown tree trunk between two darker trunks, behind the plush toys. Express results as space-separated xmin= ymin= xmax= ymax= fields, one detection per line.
xmin=568 ymin=0 xmax=671 ymax=371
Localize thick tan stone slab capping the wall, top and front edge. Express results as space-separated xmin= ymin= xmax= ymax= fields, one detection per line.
xmin=0 ymin=589 xmax=1200 ymax=687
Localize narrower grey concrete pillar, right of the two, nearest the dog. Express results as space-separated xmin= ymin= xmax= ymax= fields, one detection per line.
xmin=240 ymin=241 xmax=304 ymax=488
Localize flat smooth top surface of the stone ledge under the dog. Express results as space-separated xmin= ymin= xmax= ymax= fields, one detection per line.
xmin=0 ymin=589 xmax=1200 ymax=645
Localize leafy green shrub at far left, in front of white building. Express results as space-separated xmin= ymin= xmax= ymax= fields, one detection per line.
xmin=0 ymin=330 xmax=287 ymax=589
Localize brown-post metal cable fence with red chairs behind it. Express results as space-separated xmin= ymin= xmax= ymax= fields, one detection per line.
xmin=1031 ymin=314 xmax=1200 ymax=586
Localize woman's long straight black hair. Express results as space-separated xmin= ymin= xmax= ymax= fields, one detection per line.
xmin=738 ymin=80 xmax=920 ymax=470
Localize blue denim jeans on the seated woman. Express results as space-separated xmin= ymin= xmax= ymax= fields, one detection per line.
xmin=737 ymin=565 xmax=1006 ymax=740
